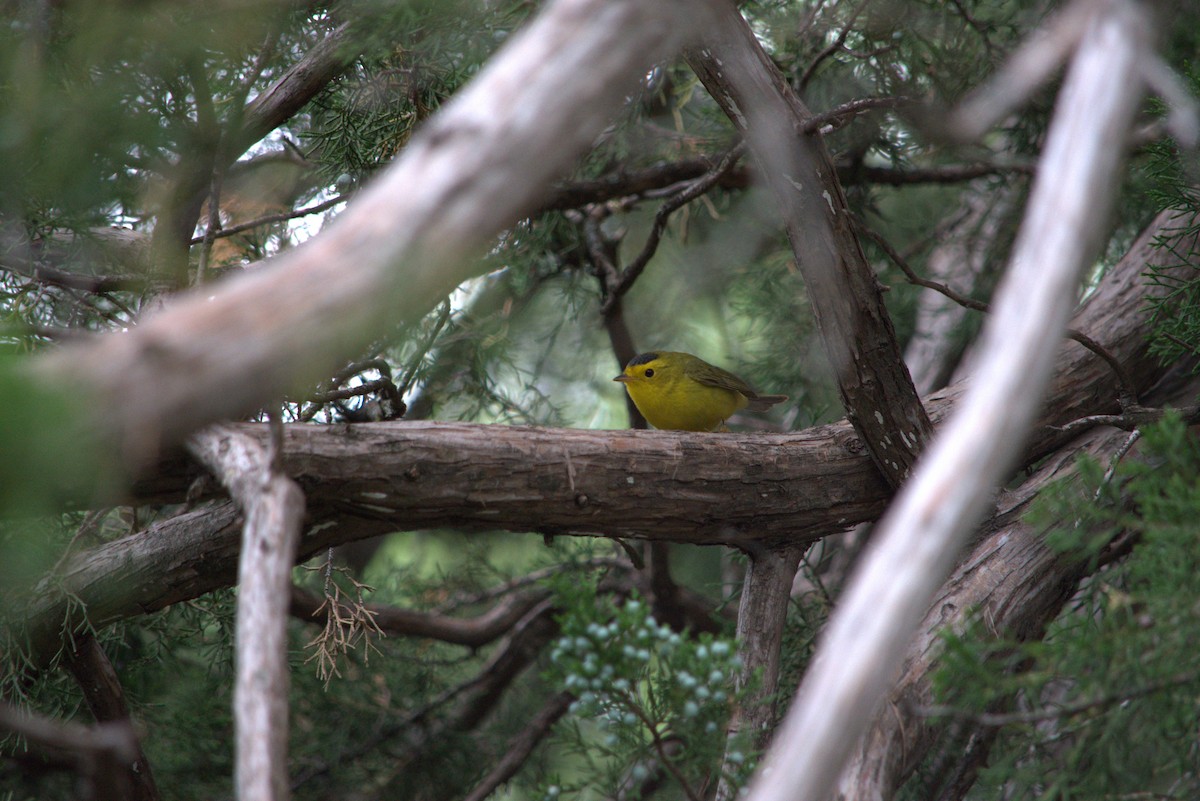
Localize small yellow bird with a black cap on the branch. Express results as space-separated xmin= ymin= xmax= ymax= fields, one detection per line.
xmin=612 ymin=350 xmax=787 ymax=432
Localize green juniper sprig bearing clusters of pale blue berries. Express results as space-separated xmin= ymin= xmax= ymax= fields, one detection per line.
xmin=544 ymin=582 xmax=755 ymax=799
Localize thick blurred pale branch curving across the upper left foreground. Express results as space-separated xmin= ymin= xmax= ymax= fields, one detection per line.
xmin=29 ymin=0 xmax=707 ymax=482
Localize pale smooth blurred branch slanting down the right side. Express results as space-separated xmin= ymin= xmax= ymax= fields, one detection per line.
xmin=750 ymin=6 xmax=1151 ymax=801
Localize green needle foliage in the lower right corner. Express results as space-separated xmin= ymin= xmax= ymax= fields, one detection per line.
xmin=921 ymin=417 xmax=1200 ymax=801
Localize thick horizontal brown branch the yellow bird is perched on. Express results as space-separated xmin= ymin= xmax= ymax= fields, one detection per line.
xmin=126 ymin=205 xmax=1190 ymax=537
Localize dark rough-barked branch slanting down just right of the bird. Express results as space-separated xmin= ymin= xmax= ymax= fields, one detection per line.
xmin=688 ymin=4 xmax=931 ymax=487
